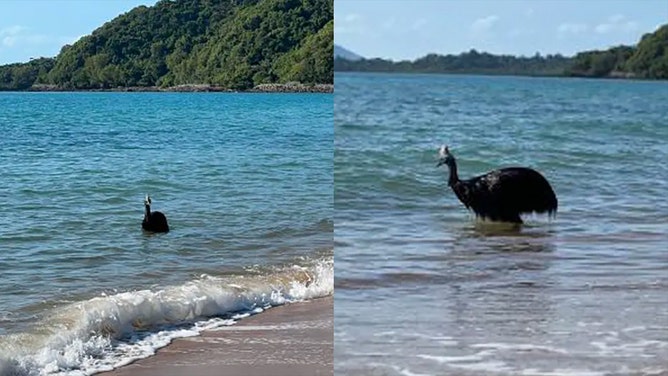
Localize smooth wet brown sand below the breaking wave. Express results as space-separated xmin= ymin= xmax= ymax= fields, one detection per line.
xmin=98 ymin=297 xmax=334 ymax=376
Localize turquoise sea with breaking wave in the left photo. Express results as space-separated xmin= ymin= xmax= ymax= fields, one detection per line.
xmin=0 ymin=93 xmax=334 ymax=375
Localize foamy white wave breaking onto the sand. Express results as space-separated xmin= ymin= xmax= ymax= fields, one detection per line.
xmin=0 ymin=258 xmax=334 ymax=376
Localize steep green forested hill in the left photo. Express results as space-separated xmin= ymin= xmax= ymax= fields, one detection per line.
xmin=0 ymin=0 xmax=334 ymax=90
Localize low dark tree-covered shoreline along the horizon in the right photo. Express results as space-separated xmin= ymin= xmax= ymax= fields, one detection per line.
xmin=334 ymin=25 xmax=668 ymax=79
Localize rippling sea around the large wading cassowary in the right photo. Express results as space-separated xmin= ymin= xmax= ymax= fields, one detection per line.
xmin=334 ymin=74 xmax=668 ymax=376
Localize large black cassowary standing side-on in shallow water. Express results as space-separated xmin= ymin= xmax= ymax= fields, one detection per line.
xmin=436 ymin=145 xmax=557 ymax=223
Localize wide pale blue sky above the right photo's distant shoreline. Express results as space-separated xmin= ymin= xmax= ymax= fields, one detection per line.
xmin=334 ymin=0 xmax=668 ymax=60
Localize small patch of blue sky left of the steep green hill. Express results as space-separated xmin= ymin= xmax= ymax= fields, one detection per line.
xmin=0 ymin=0 xmax=157 ymax=64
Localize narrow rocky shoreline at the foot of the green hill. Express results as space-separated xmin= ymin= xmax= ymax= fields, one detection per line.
xmin=27 ymin=83 xmax=334 ymax=93
